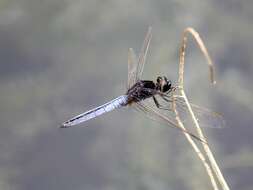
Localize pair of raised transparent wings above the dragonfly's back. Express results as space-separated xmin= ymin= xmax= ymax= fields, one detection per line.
xmin=127 ymin=27 xmax=152 ymax=89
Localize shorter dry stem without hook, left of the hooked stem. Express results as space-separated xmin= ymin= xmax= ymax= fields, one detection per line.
xmin=172 ymin=96 xmax=218 ymax=190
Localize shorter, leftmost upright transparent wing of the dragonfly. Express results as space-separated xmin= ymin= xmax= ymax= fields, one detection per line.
xmin=127 ymin=48 xmax=137 ymax=89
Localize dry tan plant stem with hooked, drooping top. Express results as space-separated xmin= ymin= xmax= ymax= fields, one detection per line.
xmin=178 ymin=28 xmax=229 ymax=190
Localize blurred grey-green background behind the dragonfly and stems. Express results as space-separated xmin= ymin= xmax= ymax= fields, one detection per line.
xmin=0 ymin=0 xmax=253 ymax=190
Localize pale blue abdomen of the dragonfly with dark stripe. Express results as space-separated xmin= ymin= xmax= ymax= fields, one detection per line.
xmin=61 ymin=95 xmax=128 ymax=128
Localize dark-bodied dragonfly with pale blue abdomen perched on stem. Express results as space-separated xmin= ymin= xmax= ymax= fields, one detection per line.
xmin=61 ymin=27 xmax=221 ymax=141
